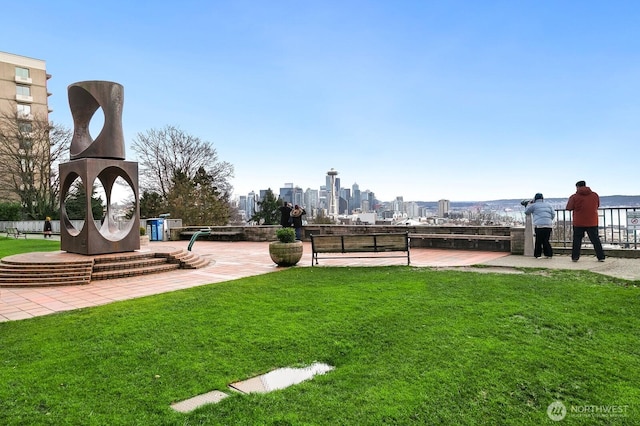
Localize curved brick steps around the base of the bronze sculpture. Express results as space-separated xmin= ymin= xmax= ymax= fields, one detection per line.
xmin=0 ymin=249 xmax=210 ymax=287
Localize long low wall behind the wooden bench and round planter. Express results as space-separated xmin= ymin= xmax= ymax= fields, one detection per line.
xmin=170 ymin=224 xmax=524 ymax=254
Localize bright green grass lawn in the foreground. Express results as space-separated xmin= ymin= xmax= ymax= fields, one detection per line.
xmin=0 ymin=266 xmax=640 ymax=425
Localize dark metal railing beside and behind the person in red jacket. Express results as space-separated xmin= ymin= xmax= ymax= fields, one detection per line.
xmin=551 ymin=207 xmax=640 ymax=250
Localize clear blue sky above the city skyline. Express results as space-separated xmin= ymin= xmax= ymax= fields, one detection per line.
xmin=0 ymin=0 xmax=640 ymax=201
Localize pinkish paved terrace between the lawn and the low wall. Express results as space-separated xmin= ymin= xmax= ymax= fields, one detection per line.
xmin=0 ymin=241 xmax=640 ymax=322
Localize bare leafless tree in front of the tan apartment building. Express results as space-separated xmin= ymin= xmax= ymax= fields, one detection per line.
xmin=0 ymin=113 xmax=73 ymax=219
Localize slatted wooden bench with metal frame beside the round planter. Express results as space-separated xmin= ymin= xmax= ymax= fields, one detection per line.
xmin=310 ymin=232 xmax=411 ymax=266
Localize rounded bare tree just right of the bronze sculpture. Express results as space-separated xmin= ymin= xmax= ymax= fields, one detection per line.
xmin=132 ymin=126 xmax=233 ymax=200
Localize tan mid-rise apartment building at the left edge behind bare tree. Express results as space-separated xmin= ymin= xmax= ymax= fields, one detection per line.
xmin=0 ymin=52 xmax=51 ymax=201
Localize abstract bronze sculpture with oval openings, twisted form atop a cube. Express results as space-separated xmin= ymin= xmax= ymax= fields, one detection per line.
xmin=60 ymin=81 xmax=140 ymax=255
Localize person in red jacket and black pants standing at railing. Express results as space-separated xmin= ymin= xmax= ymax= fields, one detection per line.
xmin=566 ymin=180 xmax=604 ymax=262
